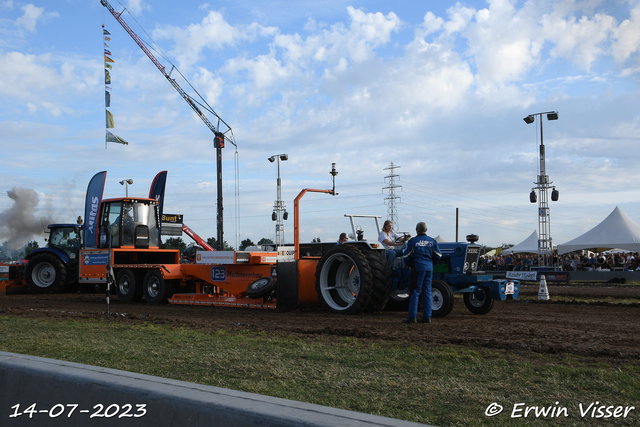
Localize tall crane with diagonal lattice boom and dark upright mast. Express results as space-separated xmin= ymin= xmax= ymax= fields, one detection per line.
xmin=100 ymin=0 xmax=238 ymax=250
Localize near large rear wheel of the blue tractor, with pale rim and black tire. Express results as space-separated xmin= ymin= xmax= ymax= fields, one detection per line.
xmin=316 ymin=244 xmax=373 ymax=314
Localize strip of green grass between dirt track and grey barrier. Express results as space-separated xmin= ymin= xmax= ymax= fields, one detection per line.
xmin=0 ymin=318 xmax=640 ymax=426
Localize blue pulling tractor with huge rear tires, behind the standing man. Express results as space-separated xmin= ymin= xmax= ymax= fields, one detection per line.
xmin=310 ymin=215 xmax=520 ymax=317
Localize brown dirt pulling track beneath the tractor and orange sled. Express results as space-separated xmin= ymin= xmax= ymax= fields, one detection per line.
xmin=0 ymin=286 xmax=640 ymax=363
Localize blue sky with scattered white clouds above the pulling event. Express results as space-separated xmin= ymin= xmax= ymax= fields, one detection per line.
xmin=0 ymin=0 xmax=640 ymax=251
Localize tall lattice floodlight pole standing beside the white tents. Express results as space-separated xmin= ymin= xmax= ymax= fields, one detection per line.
xmin=523 ymin=111 xmax=559 ymax=267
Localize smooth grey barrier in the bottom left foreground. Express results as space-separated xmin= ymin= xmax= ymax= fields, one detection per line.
xmin=0 ymin=352 xmax=432 ymax=427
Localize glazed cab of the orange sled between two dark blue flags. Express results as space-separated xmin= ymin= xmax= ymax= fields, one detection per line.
xmin=100 ymin=198 xmax=160 ymax=249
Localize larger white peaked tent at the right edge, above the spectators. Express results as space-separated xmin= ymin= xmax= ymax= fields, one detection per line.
xmin=558 ymin=206 xmax=640 ymax=255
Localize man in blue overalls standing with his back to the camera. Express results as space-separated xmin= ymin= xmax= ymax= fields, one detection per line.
xmin=402 ymin=222 xmax=442 ymax=323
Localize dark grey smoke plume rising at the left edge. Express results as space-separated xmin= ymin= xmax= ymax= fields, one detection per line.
xmin=0 ymin=187 xmax=51 ymax=249
